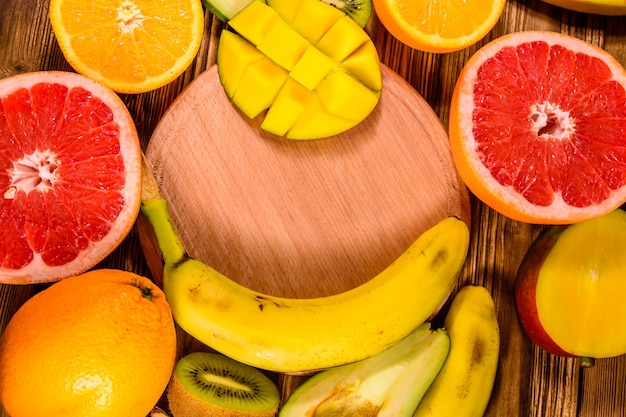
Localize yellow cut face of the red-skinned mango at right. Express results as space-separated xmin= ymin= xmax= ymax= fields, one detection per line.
xmin=536 ymin=211 xmax=626 ymax=358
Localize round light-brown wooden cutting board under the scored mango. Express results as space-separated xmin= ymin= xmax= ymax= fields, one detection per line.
xmin=146 ymin=66 xmax=469 ymax=298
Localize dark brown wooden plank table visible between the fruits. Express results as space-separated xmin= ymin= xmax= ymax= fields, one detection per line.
xmin=0 ymin=0 xmax=626 ymax=417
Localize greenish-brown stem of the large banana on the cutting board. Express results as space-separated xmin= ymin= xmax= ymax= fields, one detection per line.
xmin=141 ymin=155 xmax=187 ymax=265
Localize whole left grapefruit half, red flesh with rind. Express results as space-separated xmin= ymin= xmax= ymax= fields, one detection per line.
xmin=0 ymin=72 xmax=141 ymax=284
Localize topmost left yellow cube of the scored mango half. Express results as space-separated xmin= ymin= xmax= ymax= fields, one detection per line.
xmin=228 ymin=1 xmax=280 ymax=45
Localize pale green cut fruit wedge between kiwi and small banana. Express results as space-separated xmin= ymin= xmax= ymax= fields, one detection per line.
xmin=279 ymin=322 xmax=450 ymax=417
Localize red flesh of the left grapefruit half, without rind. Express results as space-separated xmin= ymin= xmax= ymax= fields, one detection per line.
xmin=0 ymin=83 xmax=125 ymax=269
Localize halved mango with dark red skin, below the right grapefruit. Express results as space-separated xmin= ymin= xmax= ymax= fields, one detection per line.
xmin=515 ymin=209 xmax=626 ymax=365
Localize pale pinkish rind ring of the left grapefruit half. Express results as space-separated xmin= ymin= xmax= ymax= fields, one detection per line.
xmin=0 ymin=71 xmax=141 ymax=284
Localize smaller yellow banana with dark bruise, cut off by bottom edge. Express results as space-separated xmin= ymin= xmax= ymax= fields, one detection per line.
xmin=413 ymin=285 xmax=500 ymax=417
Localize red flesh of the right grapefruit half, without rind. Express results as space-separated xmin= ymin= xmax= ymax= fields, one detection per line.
xmin=472 ymin=41 xmax=626 ymax=207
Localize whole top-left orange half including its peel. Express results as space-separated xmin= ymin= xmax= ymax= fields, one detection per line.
xmin=50 ymin=0 xmax=204 ymax=93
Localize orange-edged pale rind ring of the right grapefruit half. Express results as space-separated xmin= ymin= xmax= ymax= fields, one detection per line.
xmin=449 ymin=31 xmax=626 ymax=224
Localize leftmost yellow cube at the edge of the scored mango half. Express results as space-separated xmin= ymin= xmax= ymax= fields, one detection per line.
xmin=217 ymin=31 xmax=265 ymax=98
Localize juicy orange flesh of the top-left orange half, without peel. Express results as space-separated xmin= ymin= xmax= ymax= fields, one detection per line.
xmin=62 ymin=0 xmax=194 ymax=83
